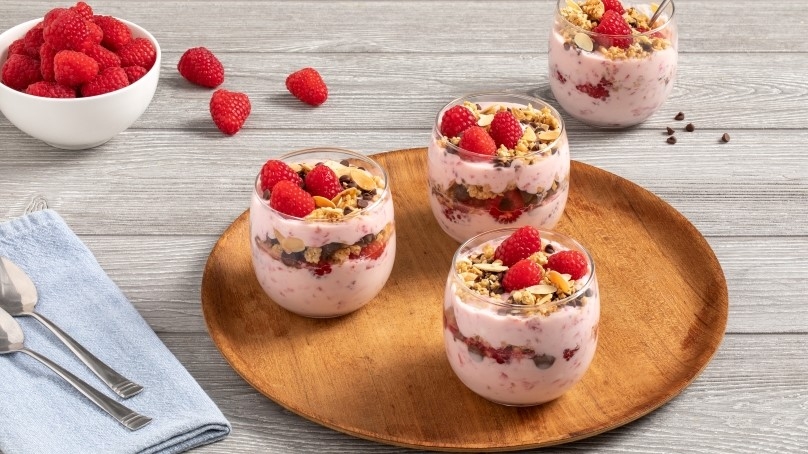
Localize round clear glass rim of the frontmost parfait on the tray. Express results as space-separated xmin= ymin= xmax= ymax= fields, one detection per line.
xmin=450 ymin=227 xmax=595 ymax=312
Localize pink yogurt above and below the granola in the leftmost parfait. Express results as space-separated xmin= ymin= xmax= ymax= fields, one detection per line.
xmin=250 ymin=168 xmax=396 ymax=317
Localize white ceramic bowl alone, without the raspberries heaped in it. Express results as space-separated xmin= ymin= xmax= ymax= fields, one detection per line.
xmin=0 ymin=18 xmax=161 ymax=150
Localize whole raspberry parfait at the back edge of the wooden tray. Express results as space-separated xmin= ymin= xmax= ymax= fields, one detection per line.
xmin=427 ymin=93 xmax=570 ymax=242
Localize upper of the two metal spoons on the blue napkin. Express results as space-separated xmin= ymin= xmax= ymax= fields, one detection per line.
xmin=0 ymin=257 xmax=143 ymax=399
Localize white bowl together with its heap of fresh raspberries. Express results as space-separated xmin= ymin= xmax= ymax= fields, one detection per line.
xmin=0 ymin=2 xmax=160 ymax=150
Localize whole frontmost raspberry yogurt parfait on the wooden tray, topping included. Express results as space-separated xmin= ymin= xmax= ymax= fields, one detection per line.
xmin=443 ymin=226 xmax=600 ymax=406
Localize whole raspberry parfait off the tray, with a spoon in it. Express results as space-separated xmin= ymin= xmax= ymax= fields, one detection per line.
xmin=548 ymin=0 xmax=678 ymax=128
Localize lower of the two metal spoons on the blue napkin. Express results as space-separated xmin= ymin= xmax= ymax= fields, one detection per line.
xmin=0 ymin=309 xmax=152 ymax=430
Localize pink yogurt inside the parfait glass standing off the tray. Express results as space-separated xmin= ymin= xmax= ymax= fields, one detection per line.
xmin=548 ymin=29 xmax=677 ymax=128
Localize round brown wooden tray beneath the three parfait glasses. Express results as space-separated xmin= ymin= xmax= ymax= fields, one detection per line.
xmin=202 ymin=148 xmax=728 ymax=451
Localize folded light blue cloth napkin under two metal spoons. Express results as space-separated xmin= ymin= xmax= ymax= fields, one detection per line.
xmin=0 ymin=210 xmax=230 ymax=454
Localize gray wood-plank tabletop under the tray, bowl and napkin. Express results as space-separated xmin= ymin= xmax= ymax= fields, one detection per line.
xmin=0 ymin=0 xmax=808 ymax=453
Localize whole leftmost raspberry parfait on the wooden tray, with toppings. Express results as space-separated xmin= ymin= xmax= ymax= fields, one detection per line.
xmin=250 ymin=148 xmax=396 ymax=317
